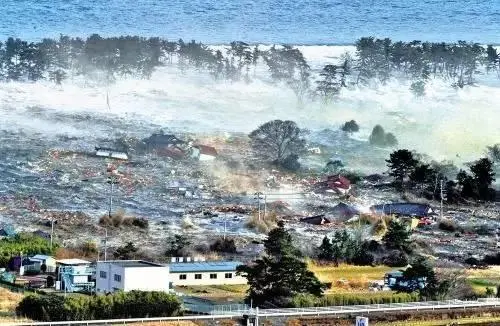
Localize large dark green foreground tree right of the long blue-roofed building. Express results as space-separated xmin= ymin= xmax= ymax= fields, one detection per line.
xmin=237 ymin=223 xmax=325 ymax=307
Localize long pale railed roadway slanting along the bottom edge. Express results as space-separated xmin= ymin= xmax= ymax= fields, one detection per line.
xmin=3 ymin=299 xmax=500 ymax=326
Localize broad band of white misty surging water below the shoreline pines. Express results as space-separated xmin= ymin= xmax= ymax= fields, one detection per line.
xmin=0 ymin=46 xmax=500 ymax=168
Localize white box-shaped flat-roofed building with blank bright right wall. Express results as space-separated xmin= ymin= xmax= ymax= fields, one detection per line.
xmin=96 ymin=260 xmax=170 ymax=294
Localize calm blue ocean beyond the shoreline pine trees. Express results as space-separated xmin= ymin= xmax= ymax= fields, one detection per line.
xmin=0 ymin=0 xmax=500 ymax=45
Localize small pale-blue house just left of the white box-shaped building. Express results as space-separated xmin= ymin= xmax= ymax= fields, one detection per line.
xmin=56 ymin=258 xmax=95 ymax=292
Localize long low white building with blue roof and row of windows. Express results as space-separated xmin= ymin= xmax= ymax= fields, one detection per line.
xmin=169 ymin=261 xmax=247 ymax=286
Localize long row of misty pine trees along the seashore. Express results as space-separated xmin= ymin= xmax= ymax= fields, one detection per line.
xmin=0 ymin=34 xmax=500 ymax=101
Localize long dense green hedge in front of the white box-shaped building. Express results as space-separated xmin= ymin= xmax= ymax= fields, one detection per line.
xmin=16 ymin=291 xmax=182 ymax=321
